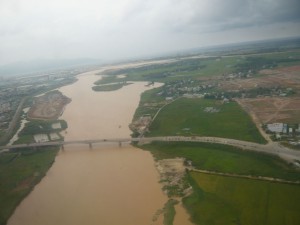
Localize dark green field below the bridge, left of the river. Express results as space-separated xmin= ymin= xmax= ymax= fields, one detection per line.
xmin=0 ymin=148 xmax=58 ymax=225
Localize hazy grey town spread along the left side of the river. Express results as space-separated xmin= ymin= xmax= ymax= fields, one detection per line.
xmin=0 ymin=66 xmax=96 ymax=142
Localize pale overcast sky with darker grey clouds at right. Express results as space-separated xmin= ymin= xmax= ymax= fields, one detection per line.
xmin=0 ymin=0 xmax=300 ymax=65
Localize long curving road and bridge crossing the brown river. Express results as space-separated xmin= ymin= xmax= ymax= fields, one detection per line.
xmin=0 ymin=136 xmax=300 ymax=166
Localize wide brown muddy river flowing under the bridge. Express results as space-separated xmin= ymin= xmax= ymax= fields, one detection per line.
xmin=8 ymin=66 xmax=192 ymax=225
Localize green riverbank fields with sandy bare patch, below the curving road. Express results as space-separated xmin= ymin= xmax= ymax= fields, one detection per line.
xmin=139 ymin=142 xmax=300 ymax=224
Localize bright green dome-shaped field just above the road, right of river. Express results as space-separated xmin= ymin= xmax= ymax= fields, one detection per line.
xmin=148 ymin=98 xmax=265 ymax=143
